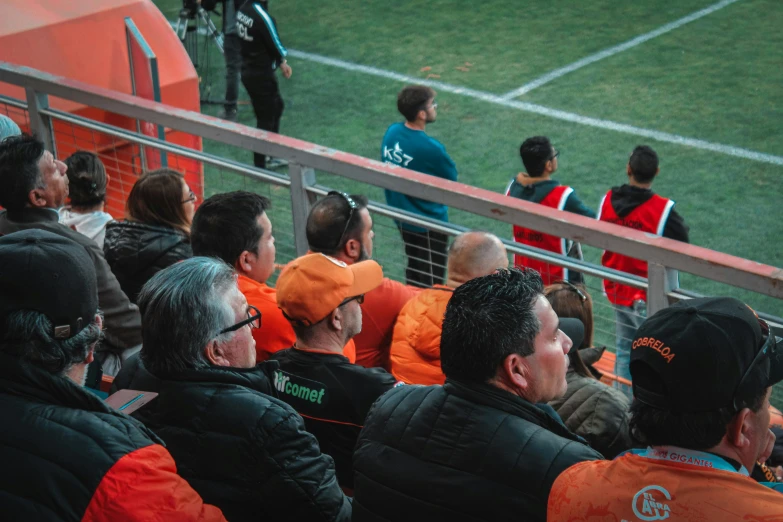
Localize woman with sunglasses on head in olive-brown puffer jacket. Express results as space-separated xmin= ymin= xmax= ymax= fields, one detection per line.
xmin=544 ymin=281 xmax=632 ymax=459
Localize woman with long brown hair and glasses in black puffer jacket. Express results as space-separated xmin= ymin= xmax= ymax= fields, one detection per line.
xmin=103 ymin=168 xmax=196 ymax=303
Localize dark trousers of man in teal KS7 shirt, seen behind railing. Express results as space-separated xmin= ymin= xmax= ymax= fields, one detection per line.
xmin=400 ymin=228 xmax=449 ymax=288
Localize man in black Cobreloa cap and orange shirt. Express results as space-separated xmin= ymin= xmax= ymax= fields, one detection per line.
xmin=548 ymin=297 xmax=783 ymax=521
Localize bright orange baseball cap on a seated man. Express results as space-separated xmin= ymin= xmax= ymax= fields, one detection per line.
xmin=275 ymin=254 xmax=383 ymax=325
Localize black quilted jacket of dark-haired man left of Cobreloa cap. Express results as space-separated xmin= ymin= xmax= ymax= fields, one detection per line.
xmin=353 ymin=379 xmax=601 ymax=522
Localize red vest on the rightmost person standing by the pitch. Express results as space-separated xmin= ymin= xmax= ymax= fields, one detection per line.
xmin=598 ymin=190 xmax=674 ymax=306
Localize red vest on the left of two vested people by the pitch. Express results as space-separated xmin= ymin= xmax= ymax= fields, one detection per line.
xmin=506 ymin=184 xmax=574 ymax=285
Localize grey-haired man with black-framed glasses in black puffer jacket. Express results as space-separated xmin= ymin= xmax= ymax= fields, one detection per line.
xmin=114 ymin=257 xmax=351 ymax=522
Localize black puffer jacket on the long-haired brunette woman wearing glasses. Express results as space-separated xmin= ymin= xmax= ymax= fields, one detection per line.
xmin=103 ymin=221 xmax=193 ymax=303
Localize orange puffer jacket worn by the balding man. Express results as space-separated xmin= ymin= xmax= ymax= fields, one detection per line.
xmin=390 ymin=285 xmax=454 ymax=385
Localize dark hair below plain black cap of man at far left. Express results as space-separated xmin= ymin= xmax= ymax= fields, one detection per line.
xmin=0 ymin=310 xmax=103 ymax=376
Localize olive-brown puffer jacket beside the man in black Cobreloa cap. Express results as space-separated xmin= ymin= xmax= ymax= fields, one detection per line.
xmin=549 ymin=348 xmax=633 ymax=459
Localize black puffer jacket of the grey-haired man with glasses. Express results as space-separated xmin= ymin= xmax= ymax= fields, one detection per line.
xmin=114 ymin=355 xmax=351 ymax=522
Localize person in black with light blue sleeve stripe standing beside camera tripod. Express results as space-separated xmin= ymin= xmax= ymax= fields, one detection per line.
xmin=237 ymin=0 xmax=291 ymax=169
